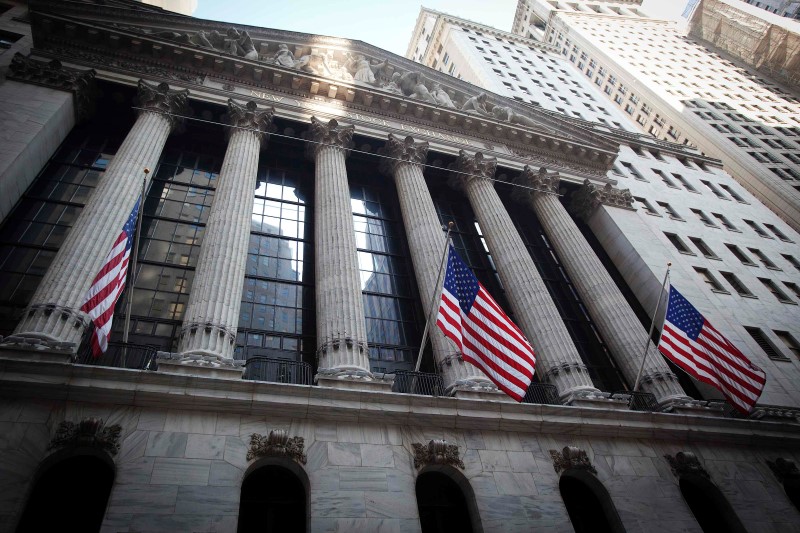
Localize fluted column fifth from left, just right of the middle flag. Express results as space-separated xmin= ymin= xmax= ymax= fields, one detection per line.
xmin=451 ymin=150 xmax=599 ymax=402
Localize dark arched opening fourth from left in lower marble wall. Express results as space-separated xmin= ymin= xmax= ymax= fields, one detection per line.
xmin=558 ymin=470 xmax=625 ymax=533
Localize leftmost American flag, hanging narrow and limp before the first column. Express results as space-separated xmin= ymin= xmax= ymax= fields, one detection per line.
xmin=81 ymin=197 xmax=141 ymax=357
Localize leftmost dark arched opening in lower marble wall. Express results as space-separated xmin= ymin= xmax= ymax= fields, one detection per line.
xmin=17 ymin=450 xmax=115 ymax=533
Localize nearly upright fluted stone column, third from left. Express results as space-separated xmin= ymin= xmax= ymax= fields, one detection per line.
xmin=308 ymin=117 xmax=390 ymax=388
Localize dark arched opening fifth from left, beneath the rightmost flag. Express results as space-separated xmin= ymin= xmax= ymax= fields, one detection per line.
xmin=679 ymin=475 xmax=747 ymax=533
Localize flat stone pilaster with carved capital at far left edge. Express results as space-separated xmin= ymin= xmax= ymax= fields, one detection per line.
xmin=0 ymin=53 xmax=95 ymax=222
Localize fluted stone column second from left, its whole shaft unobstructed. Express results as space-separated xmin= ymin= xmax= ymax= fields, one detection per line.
xmin=178 ymin=100 xmax=275 ymax=359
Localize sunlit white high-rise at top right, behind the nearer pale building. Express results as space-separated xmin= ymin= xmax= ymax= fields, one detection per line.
xmin=513 ymin=0 xmax=800 ymax=234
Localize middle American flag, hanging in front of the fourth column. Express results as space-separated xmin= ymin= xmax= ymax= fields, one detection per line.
xmin=436 ymin=245 xmax=536 ymax=402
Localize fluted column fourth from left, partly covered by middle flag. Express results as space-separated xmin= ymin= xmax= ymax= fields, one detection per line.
xmin=381 ymin=134 xmax=498 ymax=396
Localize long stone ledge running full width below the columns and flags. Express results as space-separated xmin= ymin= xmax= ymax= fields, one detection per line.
xmin=0 ymin=353 xmax=800 ymax=447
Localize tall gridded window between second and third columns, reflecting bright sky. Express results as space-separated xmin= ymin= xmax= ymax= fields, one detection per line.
xmin=236 ymin=152 xmax=316 ymax=364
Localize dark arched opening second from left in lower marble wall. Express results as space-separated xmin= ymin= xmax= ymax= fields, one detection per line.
xmin=237 ymin=464 xmax=308 ymax=533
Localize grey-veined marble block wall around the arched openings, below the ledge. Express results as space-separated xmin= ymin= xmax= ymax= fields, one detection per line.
xmin=0 ymin=398 xmax=800 ymax=533
